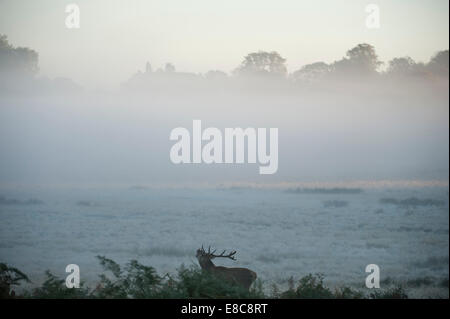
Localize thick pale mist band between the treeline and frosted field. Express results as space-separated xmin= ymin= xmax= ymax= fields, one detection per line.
xmin=0 ymin=61 xmax=449 ymax=184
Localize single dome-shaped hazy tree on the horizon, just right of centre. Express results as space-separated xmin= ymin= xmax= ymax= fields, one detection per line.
xmin=235 ymin=51 xmax=287 ymax=76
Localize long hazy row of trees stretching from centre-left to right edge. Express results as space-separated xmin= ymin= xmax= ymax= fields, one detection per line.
xmin=129 ymin=43 xmax=449 ymax=89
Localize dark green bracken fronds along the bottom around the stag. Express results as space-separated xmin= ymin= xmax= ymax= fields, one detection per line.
xmin=0 ymin=256 xmax=414 ymax=299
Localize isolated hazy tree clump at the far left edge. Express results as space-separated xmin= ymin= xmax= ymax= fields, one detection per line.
xmin=0 ymin=34 xmax=39 ymax=75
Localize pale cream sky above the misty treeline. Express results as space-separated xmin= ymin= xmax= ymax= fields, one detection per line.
xmin=0 ymin=0 xmax=449 ymax=87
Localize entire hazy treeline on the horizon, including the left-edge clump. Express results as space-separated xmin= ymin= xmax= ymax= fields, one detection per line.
xmin=0 ymin=34 xmax=449 ymax=87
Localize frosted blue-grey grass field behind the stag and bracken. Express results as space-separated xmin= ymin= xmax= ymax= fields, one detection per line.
xmin=0 ymin=187 xmax=449 ymax=296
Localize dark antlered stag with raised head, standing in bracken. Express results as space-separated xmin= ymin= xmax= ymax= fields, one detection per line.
xmin=196 ymin=246 xmax=256 ymax=290
